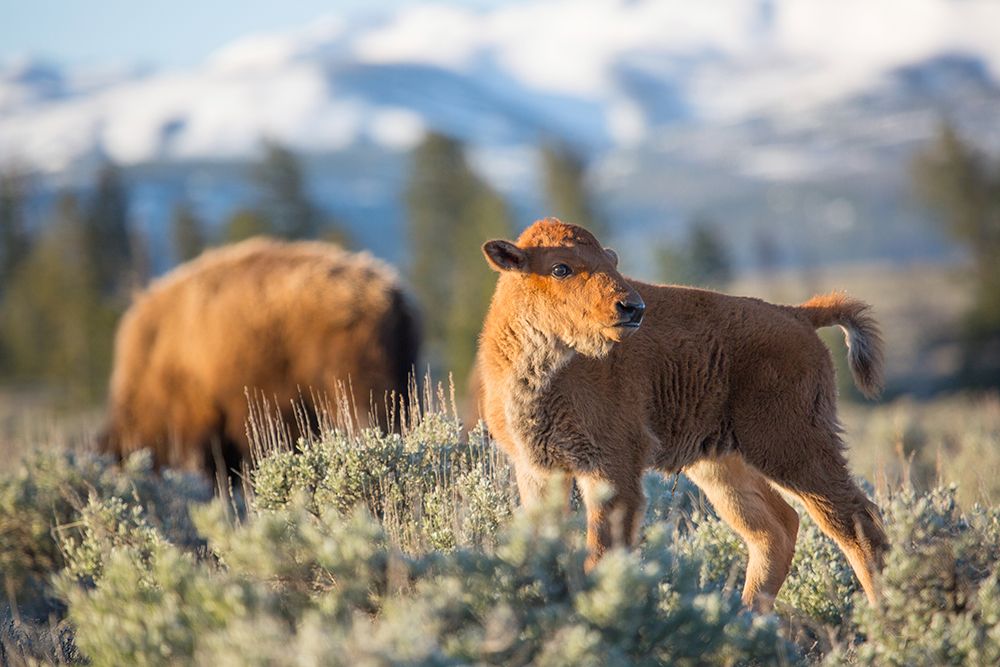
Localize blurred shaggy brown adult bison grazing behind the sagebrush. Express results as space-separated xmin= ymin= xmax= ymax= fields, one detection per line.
xmin=103 ymin=239 xmax=419 ymax=478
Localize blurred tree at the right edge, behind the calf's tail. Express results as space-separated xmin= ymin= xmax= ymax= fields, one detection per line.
xmin=913 ymin=124 xmax=1000 ymax=387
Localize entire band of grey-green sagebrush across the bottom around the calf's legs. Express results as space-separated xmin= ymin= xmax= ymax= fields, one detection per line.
xmin=0 ymin=396 xmax=1000 ymax=665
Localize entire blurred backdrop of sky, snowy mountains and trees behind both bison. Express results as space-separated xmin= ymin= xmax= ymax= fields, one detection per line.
xmin=0 ymin=0 xmax=1000 ymax=418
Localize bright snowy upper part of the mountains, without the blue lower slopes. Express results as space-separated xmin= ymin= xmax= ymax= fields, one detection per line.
xmin=0 ymin=0 xmax=1000 ymax=170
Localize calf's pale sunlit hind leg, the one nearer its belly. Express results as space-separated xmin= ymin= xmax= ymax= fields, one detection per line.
xmin=684 ymin=454 xmax=799 ymax=611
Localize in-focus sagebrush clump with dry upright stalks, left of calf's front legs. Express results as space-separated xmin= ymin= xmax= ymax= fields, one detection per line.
xmin=253 ymin=422 xmax=515 ymax=553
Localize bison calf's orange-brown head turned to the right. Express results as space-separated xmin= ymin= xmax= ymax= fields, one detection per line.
xmin=483 ymin=218 xmax=646 ymax=357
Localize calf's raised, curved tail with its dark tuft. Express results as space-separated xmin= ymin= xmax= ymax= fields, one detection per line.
xmin=798 ymin=292 xmax=884 ymax=398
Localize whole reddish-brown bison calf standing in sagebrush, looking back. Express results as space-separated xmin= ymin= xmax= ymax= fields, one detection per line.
xmin=479 ymin=219 xmax=887 ymax=609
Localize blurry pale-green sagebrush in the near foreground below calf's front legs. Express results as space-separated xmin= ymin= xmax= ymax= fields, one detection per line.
xmin=62 ymin=488 xmax=795 ymax=665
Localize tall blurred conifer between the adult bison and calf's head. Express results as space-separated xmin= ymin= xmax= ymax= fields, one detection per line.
xmin=406 ymin=134 xmax=512 ymax=382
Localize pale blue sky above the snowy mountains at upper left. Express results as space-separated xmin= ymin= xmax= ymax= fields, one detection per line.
xmin=0 ymin=0 xmax=508 ymax=67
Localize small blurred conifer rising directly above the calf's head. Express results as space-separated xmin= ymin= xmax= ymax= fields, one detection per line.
xmin=542 ymin=144 xmax=608 ymax=242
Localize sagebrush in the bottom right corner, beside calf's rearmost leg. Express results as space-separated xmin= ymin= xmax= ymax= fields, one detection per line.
xmin=835 ymin=487 xmax=1000 ymax=665
